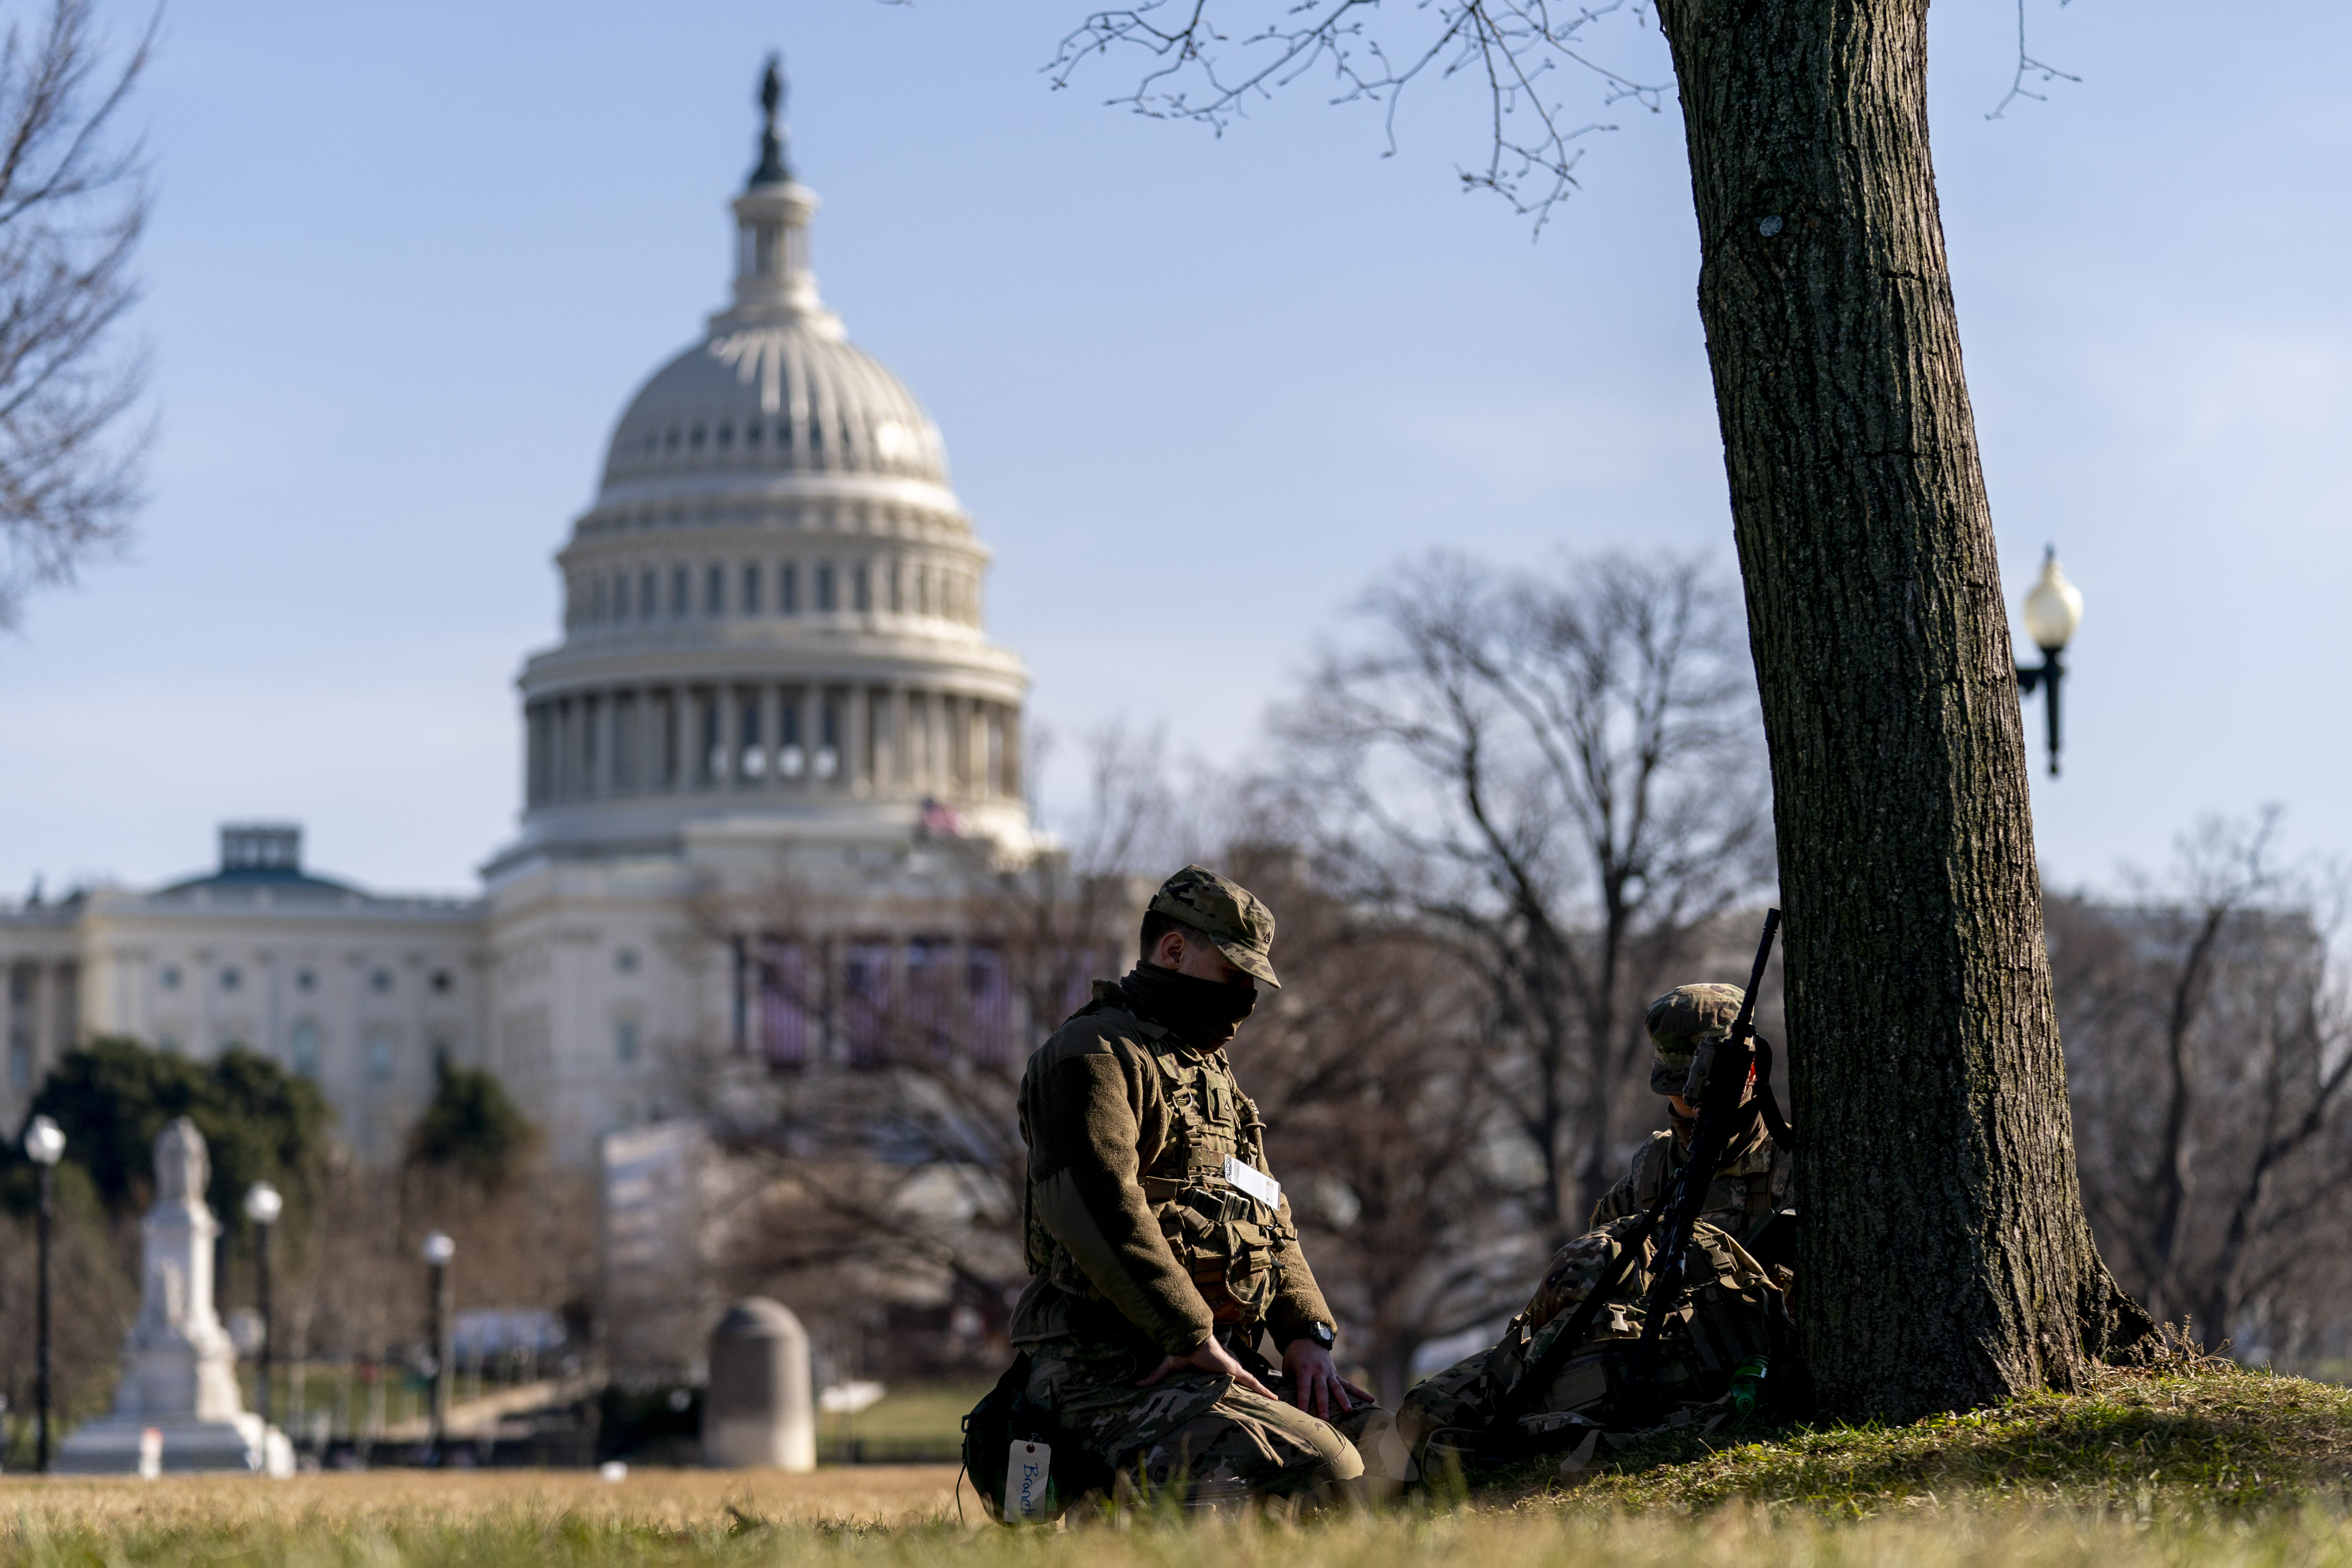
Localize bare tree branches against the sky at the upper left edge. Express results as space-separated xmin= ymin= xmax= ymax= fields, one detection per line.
xmin=0 ymin=0 xmax=160 ymax=625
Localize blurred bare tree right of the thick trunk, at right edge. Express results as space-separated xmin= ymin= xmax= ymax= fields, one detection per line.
xmin=2049 ymin=811 xmax=2352 ymax=1342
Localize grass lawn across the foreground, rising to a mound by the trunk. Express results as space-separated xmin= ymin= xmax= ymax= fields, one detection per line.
xmin=14 ymin=1370 xmax=2352 ymax=1568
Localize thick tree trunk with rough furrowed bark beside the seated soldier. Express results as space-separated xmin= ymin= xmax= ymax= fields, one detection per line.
xmin=1660 ymin=0 xmax=2147 ymax=1420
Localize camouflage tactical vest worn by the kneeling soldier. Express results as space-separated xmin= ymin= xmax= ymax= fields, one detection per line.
xmin=1028 ymin=980 xmax=1298 ymax=1326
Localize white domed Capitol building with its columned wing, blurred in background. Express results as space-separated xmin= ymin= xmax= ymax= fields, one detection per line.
xmin=0 ymin=80 xmax=1037 ymax=1168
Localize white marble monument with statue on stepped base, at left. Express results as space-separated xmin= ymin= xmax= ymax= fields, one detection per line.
xmin=56 ymin=1116 xmax=294 ymax=1477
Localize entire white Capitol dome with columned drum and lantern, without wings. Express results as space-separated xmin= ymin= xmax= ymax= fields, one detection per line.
xmin=505 ymin=83 xmax=1028 ymax=872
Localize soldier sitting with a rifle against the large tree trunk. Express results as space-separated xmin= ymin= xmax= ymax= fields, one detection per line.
xmin=1397 ymin=985 xmax=1792 ymax=1467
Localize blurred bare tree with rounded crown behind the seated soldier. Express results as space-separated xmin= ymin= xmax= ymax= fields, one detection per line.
xmin=1279 ymin=555 xmax=1771 ymax=1243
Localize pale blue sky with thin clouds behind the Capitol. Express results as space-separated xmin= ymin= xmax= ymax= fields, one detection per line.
xmin=0 ymin=0 xmax=2352 ymax=896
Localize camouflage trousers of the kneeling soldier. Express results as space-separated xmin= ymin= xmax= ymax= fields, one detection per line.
xmin=1028 ymin=1340 xmax=1409 ymax=1509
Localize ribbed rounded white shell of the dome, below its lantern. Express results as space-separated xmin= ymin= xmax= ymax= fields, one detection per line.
xmin=604 ymin=315 xmax=948 ymax=489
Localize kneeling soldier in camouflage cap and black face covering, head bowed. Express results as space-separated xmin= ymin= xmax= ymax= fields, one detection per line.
xmin=1011 ymin=865 xmax=1409 ymax=1507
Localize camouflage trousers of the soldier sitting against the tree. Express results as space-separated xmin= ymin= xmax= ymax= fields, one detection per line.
xmin=1397 ymin=1215 xmax=1771 ymax=1469
